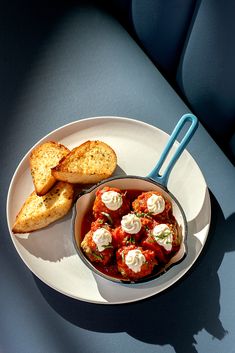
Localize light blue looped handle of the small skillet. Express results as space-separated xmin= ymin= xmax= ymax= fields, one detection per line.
xmin=147 ymin=114 xmax=198 ymax=187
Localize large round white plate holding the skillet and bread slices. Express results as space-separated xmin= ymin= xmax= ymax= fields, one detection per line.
xmin=7 ymin=117 xmax=211 ymax=304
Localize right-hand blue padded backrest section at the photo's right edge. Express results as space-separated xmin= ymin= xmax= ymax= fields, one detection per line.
xmin=177 ymin=0 xmax=235 ymax=155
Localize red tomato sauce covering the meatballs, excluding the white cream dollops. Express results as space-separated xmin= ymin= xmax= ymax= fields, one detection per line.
xmin=81 ymin=187 xmax=180 ymax=281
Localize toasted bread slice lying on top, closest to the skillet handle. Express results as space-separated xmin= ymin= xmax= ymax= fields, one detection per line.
xmin=52 ymin=141 xmax=117 ymax=184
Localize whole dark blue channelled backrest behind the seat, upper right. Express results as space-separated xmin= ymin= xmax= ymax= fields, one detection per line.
xmin=131 ymin=0 xmax=235 ymax=161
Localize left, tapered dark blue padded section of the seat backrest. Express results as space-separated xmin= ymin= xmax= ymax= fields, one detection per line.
xmin=131 ymin=0 xmax=195 ymax=80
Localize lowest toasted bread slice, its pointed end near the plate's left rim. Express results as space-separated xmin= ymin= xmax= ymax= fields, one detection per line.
xmin=12 ymin=182 xmax=74 ymax=233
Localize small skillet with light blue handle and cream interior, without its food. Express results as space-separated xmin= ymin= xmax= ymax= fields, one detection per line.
xmin=72 ymin=114 xmax=198 ymax=284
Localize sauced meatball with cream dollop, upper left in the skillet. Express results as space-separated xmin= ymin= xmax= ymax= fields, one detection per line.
xmin=93 ymin=186 xmax=130 ymax=226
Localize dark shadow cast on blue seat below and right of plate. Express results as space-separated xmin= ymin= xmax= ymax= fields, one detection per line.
xmin=35 ymin=190 xmax=235 ymax=353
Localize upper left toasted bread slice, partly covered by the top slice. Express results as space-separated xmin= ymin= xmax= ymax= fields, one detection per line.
xmin=29 ymin=141 xmax=70 ymax=196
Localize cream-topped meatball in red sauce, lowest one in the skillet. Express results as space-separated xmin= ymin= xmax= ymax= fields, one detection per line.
xmin=116 ymin=245 xmax=157 ymax=281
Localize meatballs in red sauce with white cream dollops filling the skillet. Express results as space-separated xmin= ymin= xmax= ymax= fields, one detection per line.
xmin=81 ymin=187 xmax=182 ymax=281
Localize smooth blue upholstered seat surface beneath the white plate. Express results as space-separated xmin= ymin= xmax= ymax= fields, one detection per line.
xmin=0 ymin=2 xmax=235 ymax=353
